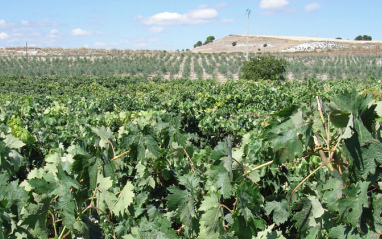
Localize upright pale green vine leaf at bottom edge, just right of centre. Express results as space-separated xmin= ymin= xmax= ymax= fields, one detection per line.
xmin=199 ymin=194 xmax=224 ymax=238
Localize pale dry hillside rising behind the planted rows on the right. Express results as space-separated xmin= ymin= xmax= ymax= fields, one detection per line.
xmin=192 ymin=35 xmax=382 ymax=53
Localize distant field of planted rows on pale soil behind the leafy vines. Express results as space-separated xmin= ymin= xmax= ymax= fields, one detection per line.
xmin=0 ymin=52 xmax=382 ymax=80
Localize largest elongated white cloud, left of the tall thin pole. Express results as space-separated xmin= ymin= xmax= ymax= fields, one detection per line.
xmin=136 ymin=5 xmax=222 ymax=26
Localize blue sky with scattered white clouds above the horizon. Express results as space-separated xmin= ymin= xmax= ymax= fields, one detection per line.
xmin=0 ymin=0 xmax=382 ymax=50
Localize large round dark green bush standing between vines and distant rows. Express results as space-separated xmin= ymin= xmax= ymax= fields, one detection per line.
xmin=240 ymin=56 xmax=288 ymax=81
